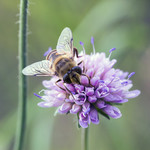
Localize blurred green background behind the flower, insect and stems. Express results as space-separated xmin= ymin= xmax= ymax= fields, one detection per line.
xmin=0 ymin=0 xmax=150 ymax=150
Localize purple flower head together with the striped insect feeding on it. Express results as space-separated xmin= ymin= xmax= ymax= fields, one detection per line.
xmin=22 ymin=28 xmax=140 ymax=128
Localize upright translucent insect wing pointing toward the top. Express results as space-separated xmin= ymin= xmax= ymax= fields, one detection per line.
xmin=56 ymin=27 xmax=73 ymax=55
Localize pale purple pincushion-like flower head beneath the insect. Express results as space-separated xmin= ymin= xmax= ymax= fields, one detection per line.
xmin=35 ymin=38 xmax=140 ymax=128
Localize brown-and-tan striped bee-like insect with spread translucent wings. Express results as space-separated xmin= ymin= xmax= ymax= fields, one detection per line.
xmin=22 ymin=27 xmax=89 ymax=89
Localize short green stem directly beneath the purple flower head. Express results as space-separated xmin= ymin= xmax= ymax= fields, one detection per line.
xmin=81 ymin=128 xmax=89 ymax=150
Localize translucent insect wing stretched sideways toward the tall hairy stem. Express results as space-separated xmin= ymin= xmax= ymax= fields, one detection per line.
xmin=22 ymin=60 xmax=54 ymax=76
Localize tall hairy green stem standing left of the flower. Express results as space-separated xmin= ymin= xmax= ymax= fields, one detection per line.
xmin=14 ymin=0 xmax=28 ymax=150
